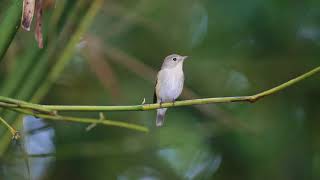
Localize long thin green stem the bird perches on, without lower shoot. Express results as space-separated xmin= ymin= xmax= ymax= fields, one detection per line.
xmin=0 ymin=66 xmax=320 ymax=114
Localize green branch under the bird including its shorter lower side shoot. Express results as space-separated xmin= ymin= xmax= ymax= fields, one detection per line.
xmin=0 ymin=66 xmax=320 ymax=132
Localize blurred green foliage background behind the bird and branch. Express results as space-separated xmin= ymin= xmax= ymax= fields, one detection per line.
xmin=0 ymin=0 xmax=320 ymax=180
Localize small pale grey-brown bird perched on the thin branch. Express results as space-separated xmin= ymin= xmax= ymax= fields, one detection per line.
xmin=153 ymin=54 xmax=188 ymax=127
